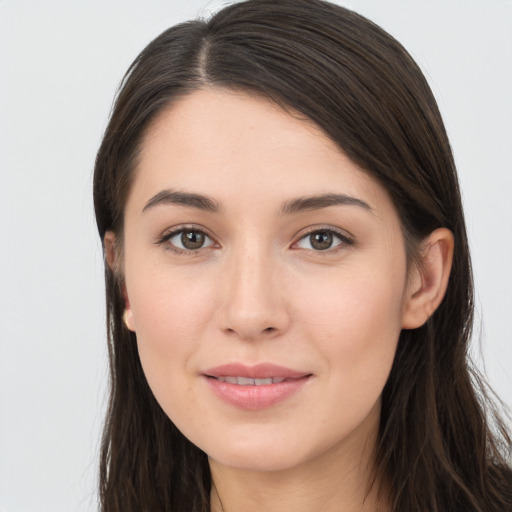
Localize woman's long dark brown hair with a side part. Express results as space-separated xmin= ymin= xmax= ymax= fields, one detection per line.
xmin=94 ymin=0 xmax=512 ymax=512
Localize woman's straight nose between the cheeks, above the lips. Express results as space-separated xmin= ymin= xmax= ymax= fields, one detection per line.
xmin=218 ymin=243 xmax=290 ymax=341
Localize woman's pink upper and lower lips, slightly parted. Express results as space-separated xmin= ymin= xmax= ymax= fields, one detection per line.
xmin=202 ymin=363 xmax=312 ymax=410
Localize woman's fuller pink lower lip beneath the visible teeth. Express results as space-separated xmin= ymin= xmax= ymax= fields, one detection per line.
xmin=205 ymin=375 xmax=311 ymax=411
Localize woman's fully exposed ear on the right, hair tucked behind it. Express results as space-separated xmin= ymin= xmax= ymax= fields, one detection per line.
xmin=402 ymin=228 xmax=454 ymax=329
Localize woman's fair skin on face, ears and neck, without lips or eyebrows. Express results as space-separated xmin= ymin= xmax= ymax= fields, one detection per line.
xmin=105 ymin=88 xmax=453 ymax=512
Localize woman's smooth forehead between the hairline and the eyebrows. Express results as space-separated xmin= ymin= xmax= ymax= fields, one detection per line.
xmin=131 ymin=88 xmax=388 ymax=216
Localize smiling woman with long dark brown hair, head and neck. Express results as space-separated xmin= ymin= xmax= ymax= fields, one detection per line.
xmin=94 ymin=0 xmax=512 ymax=512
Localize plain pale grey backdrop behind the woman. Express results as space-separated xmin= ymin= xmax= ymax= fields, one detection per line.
xmin=0 ymin=0 xmax=512 ymax=512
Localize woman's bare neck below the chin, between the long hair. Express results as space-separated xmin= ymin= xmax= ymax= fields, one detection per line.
xmin=210 ymin=404 xmax=390 ymax=512
